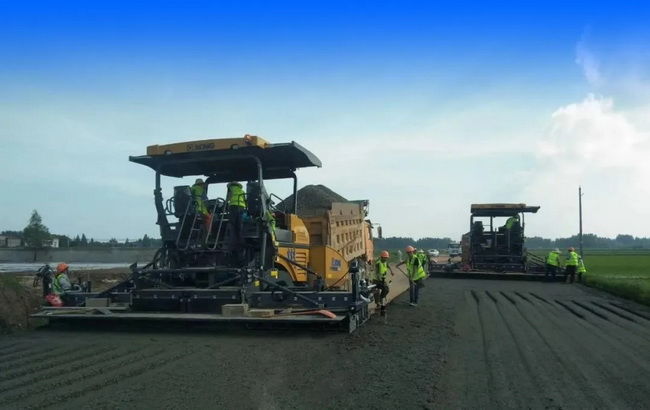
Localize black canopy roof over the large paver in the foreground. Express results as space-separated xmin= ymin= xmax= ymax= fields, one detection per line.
xmin=129 ymin=142 xmax=322 ymax=183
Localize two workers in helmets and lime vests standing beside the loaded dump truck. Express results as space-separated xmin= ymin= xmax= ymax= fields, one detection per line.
xmin=372 ymin=245 xmax=428 ymax=315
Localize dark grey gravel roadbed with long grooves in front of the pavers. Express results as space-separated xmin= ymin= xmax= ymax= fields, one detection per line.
xmin=0 ymin=271 xmax=650 ymax=409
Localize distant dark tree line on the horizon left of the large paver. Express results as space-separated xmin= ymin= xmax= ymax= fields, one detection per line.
xmin=0 ymin=210 xmax=162 ymax=249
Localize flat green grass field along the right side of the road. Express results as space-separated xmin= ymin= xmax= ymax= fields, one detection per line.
xmin=377 ymin=249 xmax=650 ymax=306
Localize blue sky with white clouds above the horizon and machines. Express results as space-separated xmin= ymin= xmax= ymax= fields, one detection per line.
xmin=0 ymin=1 xmax=650 ymax=239
